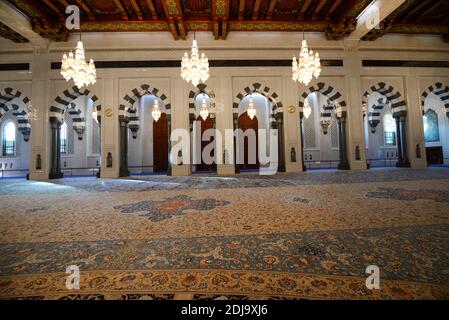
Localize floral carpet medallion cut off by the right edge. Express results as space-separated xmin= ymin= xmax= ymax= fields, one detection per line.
xmin=366 ymin=188 xmax=449 ymax=202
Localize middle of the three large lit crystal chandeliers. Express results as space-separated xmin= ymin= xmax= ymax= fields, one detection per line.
xmin=181 ymin=39 xmax=209 ymax=87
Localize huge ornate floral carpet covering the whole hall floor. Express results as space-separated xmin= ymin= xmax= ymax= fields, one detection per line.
xmin=0 ymin=169 xmax=449 ymax=299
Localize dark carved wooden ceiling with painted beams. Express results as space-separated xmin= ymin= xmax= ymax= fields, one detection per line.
xmin=0 ymin=0 xmax=449 ymax=42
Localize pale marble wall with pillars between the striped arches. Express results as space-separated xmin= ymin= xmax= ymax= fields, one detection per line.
xmin=0 ymin=32 xmax=449 ymax=179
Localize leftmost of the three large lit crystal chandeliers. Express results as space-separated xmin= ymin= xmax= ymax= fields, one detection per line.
xmin=61 ymin=40 xmax=97 ymax=89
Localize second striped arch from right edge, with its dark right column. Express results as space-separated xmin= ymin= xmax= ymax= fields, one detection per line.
xmin=363 ymin=82 xmax=410 ymax=168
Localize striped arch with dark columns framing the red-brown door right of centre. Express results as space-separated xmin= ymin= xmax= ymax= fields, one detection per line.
xmin=232 ymin=82 xmax=285 ymax=173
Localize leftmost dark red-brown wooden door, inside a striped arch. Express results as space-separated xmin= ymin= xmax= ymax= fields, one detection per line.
xmin=153 ymin=113 xmax=168 ymax=172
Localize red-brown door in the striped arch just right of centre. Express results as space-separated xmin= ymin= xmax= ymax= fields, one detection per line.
xmin=237 ymin=112 xmax=259 ymax=170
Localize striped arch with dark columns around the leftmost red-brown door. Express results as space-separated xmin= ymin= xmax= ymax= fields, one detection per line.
xmin=119 ymin=84 xmax=172 ymax=177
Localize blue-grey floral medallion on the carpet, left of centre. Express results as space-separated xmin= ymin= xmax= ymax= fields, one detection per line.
xmin=114 ymin=195 xmax=230 ymax=222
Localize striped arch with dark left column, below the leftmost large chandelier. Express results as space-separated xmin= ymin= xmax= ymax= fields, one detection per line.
xmin=49 ymin=86 xmax=101 ymax=179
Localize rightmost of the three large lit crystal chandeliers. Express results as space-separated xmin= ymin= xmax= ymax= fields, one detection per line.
xmin=292 ymin=40 xmax=321 ymax=85
